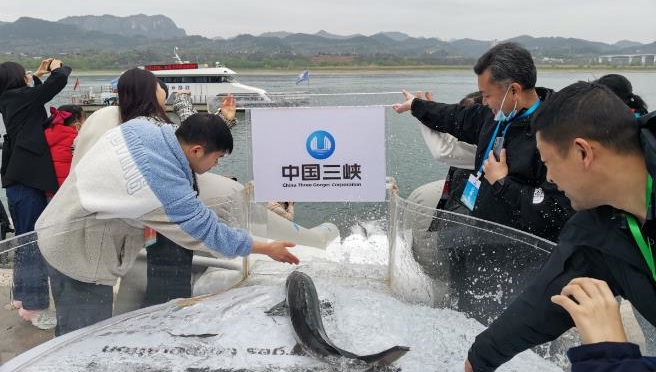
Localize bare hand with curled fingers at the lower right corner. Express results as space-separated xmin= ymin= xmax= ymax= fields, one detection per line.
xmin=551 ymin=278 xmax=626 ymax=344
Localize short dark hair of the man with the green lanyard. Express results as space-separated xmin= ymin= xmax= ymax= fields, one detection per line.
xmin=531 ymin=81 xmax=642 ymax=154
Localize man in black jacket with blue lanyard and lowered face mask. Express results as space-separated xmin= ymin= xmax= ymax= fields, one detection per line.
xmin=393 ymin=43 xmax=572 ymax=241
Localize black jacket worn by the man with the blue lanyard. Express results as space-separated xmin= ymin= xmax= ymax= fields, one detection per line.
xmin=412 ymin=88 xmax=573 ymax=241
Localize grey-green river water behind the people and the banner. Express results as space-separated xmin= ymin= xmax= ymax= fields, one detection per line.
xmin=1 ymin=70 xmax=656 ymax=236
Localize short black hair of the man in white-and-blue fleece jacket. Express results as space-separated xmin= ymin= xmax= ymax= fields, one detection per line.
xmin=175 ymin=112 xmax=233 ymax=154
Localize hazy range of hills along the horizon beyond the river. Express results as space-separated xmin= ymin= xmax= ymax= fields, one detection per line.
xmin=0 ymin=14 xmax=656 ymax=69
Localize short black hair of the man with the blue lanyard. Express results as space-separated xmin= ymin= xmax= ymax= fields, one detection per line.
xmin=474 ymin=43 xmax=538 ymax=89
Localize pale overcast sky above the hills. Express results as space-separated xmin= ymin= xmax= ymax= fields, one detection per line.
xmin=0 ymin=0 xmax=656 ymax=43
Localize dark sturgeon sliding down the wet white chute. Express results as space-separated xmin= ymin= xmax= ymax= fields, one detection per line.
xmin=266 ymin=271 xmax=410 ymax=371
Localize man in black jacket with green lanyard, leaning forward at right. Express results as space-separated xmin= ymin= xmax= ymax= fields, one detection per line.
xmin=465 ymin=82 xmax=656 ymax=372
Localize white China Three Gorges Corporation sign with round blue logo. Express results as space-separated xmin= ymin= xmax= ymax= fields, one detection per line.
xmin=251 ymin=107 xmax=386 ymax=202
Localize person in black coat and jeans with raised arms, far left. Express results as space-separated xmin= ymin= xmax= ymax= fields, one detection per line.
xmin=0 ymin=58 xmax=71 ymax=328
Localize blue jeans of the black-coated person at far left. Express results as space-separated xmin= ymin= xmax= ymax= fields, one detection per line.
xmin=7 ymin=184 xmax=50 ymax=310
